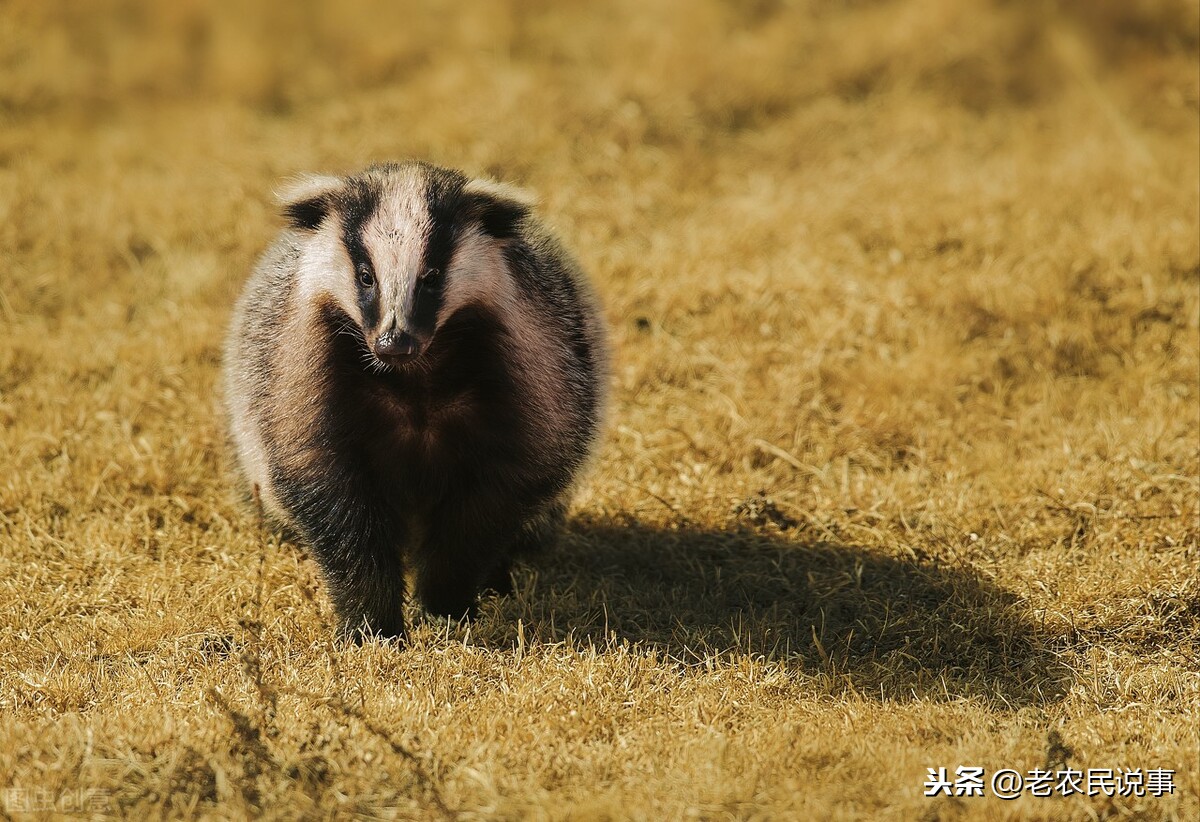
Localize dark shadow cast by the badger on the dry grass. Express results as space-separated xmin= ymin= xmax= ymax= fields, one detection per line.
xmin=479 ymin=521 xmax=1070 ymax=708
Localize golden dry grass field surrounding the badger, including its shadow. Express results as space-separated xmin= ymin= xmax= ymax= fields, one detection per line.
xmin=0 ymin=0 xmax=1200 ymax=820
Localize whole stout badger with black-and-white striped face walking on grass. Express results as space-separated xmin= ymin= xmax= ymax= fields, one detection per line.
xmin=224 ymin=161 xmax=607 ymax=638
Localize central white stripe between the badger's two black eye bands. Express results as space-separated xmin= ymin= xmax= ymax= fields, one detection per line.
xmin=362 ymin=174 xmax=431 ymax=328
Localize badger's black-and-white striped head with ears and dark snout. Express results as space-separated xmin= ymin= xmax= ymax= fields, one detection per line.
xmin=282 ymin=162 xmax=530 ymax=370
